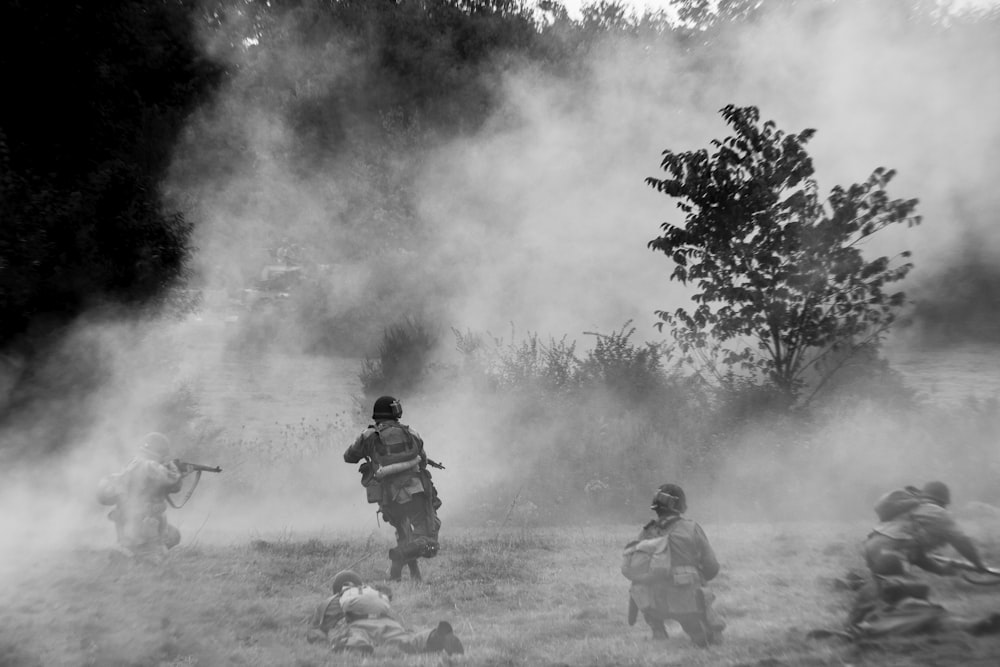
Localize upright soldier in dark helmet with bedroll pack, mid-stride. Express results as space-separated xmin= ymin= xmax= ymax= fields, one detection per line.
xmin=344 ymin=396 xmax=441 ymax=581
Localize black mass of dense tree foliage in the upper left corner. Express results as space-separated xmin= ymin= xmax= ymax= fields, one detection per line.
xmin=0 ymin=0 xmax=219 ymax=345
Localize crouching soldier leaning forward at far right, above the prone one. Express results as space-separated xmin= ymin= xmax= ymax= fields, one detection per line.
xmin=864 ymin=482 xmax=988 ymax=575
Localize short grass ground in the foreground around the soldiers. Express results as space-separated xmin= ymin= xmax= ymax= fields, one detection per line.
xmin=0 ymin=523 xmax=1000 ymax=667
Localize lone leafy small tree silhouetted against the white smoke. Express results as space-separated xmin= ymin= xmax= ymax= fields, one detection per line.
xmin=646 ymin=105 xmax=920 ymax=403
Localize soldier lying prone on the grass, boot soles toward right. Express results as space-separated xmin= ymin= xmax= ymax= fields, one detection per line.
xmin=306 ymin=570 xmax=465 ymax=655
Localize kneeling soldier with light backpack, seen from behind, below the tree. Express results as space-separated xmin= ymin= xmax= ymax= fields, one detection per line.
xmin=622 ymin=484 xmax=726 ymax=647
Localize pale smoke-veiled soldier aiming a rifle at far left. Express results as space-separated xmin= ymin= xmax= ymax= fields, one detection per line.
xmin=97 ymin=433 xmax=183 ymax=562
